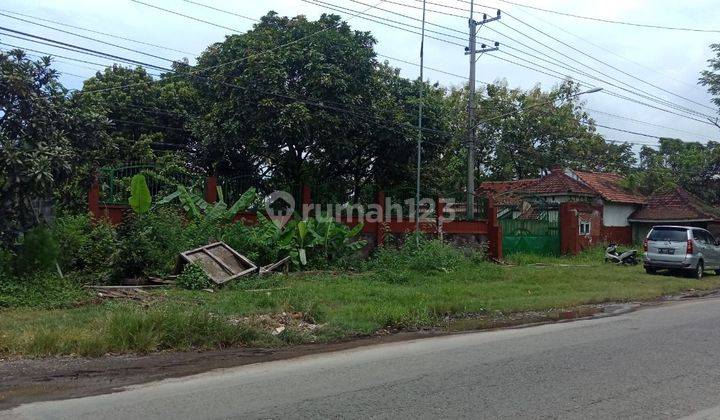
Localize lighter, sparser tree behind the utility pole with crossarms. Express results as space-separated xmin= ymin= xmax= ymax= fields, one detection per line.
xmin=430 ymin=82 xmax=635 ymax=189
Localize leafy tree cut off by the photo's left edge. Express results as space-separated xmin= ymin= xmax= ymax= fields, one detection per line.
xmin=0 ymin=50 xmax=102 ymax=243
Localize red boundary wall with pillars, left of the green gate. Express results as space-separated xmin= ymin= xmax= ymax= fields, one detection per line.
xmin=88 ymin=177 xmax=502 ymax=260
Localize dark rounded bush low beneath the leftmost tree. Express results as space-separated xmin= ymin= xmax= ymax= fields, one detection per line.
xmin=15 ymin=226 xmax=60 ymax=274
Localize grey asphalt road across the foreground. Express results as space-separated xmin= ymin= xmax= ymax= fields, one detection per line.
xmin=0 ymin=299 xmax=720 ymax=420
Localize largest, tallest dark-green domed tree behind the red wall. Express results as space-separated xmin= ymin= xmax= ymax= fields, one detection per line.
xmin=188 ymin=13 xmax=452 ymax=199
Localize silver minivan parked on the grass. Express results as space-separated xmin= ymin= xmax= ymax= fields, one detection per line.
xmin=643 ymin=226 xmax=720 ymax=279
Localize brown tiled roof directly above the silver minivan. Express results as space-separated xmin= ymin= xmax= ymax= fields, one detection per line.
xmin=628 ymin=187 xmax=720 ymax=221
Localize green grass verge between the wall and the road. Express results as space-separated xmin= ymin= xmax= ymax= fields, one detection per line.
xmin=0 ymin=252 xmax=720 ymax=356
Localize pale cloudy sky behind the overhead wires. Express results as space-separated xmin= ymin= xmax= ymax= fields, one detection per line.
xmin=0 ymin=0 xmax=720 ymax=151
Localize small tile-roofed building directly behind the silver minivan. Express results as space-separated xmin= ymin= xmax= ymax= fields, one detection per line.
xmin=628 ymin=187 xmax=720 ymax=241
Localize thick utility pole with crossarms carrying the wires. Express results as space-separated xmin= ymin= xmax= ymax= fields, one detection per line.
xmin=465 ymin=0 xmax=500 ymax=220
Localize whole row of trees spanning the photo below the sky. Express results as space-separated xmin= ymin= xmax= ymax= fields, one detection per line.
xmin=0 ymin=13 xmax=720 ymax=241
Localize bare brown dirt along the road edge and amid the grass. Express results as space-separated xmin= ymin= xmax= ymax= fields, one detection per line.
xmin=0 ymin=291 xmax=718 ymax=410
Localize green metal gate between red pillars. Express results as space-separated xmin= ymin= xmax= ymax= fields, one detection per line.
xmin=499 ymin=219 xmax=560 ymax=255
